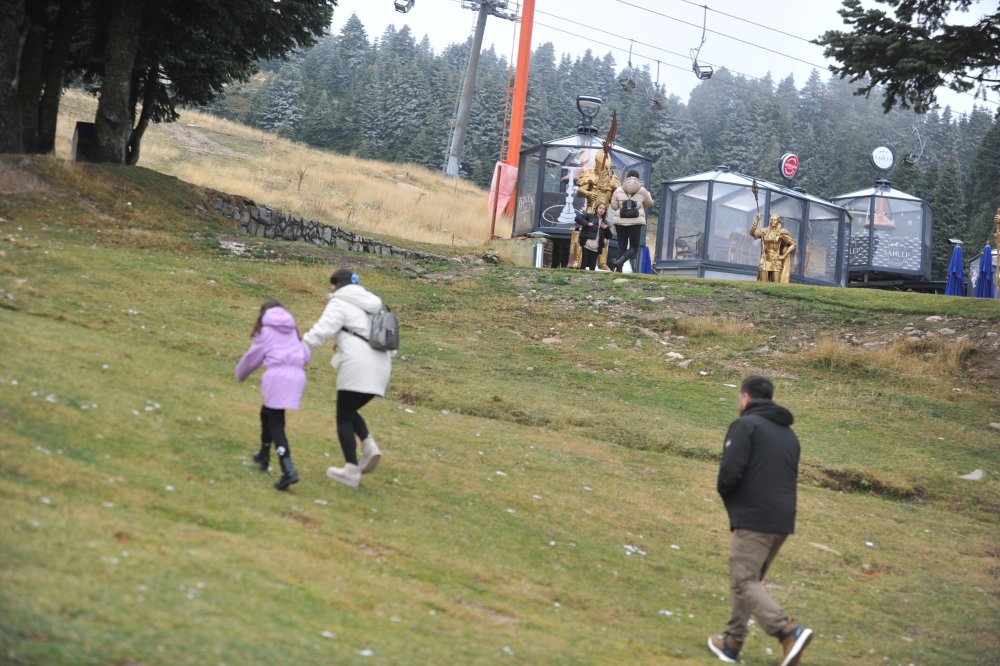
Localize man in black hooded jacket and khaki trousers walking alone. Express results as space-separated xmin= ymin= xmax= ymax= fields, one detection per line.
xmin=708 ymin=376 xmax=813 ymax=666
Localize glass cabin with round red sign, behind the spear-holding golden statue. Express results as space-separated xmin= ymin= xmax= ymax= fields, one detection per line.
xmin=653 ymin=167 xmax=851 ymax=287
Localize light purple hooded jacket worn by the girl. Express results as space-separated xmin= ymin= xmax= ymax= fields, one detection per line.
xmin=236 ymin=307 xmax=312 ymax=409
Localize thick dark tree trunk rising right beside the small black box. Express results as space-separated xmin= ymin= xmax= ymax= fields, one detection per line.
xmin=94 ymin=0 xmax=143 ymax=164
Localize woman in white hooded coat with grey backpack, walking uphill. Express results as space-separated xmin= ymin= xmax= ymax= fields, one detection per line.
xmin=302 ymin=268 xmax=392 ymax=488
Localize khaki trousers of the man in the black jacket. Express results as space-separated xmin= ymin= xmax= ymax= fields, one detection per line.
xmin=726 ymin=529 xmax=788 ymax=641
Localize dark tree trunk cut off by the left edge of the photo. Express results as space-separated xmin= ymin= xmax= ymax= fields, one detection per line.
xmin=0 ymin=0 xmax=27 ymax=153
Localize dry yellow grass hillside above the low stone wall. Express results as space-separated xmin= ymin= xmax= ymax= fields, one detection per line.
xmin=50 ymin=90 xmax=511 ymax=247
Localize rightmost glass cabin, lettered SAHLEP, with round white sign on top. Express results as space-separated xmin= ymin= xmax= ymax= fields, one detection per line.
xmin=833 ymin=179 xmax=932 ymax=281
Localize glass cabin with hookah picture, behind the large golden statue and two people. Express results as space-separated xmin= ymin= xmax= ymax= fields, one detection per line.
xmin=512 ymin=134 xmax=652 ymax=266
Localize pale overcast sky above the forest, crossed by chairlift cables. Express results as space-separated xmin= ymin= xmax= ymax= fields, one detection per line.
xmin=333 ymin=0 xmax=998 ymax=113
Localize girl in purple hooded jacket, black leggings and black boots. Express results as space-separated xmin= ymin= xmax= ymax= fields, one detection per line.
xmin=236 ymin=300 xmax=312 ymax=490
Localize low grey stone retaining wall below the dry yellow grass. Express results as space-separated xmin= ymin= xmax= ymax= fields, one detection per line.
xmin=208 ymin=190 xmax=448 ymax=261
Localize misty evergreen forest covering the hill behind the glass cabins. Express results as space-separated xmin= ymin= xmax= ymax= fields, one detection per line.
xmin=206 ymin=16 xmax=1000 ymax=277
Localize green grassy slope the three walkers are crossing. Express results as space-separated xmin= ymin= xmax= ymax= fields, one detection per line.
xmin=0 ymin=160 xmax=1000 ymax=664
